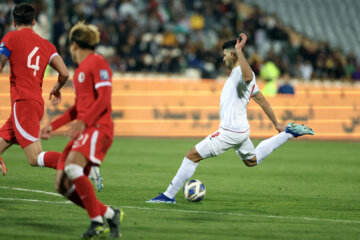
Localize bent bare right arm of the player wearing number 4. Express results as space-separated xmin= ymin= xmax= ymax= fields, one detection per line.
xmin=49 ymin=55 xmax=69 ymax=104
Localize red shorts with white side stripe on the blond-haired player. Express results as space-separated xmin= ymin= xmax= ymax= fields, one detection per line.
xmin=56 ymin=127 xmax=112 ymax=170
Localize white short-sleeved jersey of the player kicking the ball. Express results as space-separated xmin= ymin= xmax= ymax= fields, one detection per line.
xmin=220 ymin=66 xmax=259 ymax=132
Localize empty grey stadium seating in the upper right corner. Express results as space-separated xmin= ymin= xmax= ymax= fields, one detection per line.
xmin=244 ymin=0 xmax=360 ymax=58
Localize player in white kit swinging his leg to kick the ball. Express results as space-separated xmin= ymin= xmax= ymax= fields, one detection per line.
xmin=147 ymin=33 xmax=314 ymax=203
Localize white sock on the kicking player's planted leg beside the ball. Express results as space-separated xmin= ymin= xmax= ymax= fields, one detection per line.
xmin=164 ymin=157 xmax=199 ymax=198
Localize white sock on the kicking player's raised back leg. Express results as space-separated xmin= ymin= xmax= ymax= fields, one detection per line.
xmin=255 ymin=132 xmax=294 ymax=164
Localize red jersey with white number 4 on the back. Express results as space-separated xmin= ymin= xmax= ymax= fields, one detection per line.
xmin=1 ymin=28 xmax=58 ymax=105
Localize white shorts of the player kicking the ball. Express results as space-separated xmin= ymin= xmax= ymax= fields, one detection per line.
xmin=195 ymin=128 xmax=255 ymax=160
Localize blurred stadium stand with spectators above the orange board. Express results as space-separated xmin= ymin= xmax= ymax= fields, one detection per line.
xmin=0 ymin=0 xmax=360 ymax=81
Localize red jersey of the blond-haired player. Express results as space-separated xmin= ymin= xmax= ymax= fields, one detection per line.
xmin=73 ymin=53 xmax=114 ymax=137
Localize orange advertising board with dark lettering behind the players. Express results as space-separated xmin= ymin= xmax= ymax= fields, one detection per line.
xmin=0 ymin=75 xmax=360 ymax=140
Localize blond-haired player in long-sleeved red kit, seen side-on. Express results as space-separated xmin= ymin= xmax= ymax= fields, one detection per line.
xmin=41 ymin=22 xmax=123 ymax=238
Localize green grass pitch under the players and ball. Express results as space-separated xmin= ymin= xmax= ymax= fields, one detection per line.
xmin=0 ymin=137 xmax=360 ymax=240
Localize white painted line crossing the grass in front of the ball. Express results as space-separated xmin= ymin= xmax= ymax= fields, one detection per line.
xmin=0 ymin=197 xmax=360 ymax=223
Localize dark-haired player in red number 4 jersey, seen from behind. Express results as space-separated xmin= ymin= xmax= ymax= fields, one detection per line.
xmin=0 ymin=4 xmax=69 ymax=175
